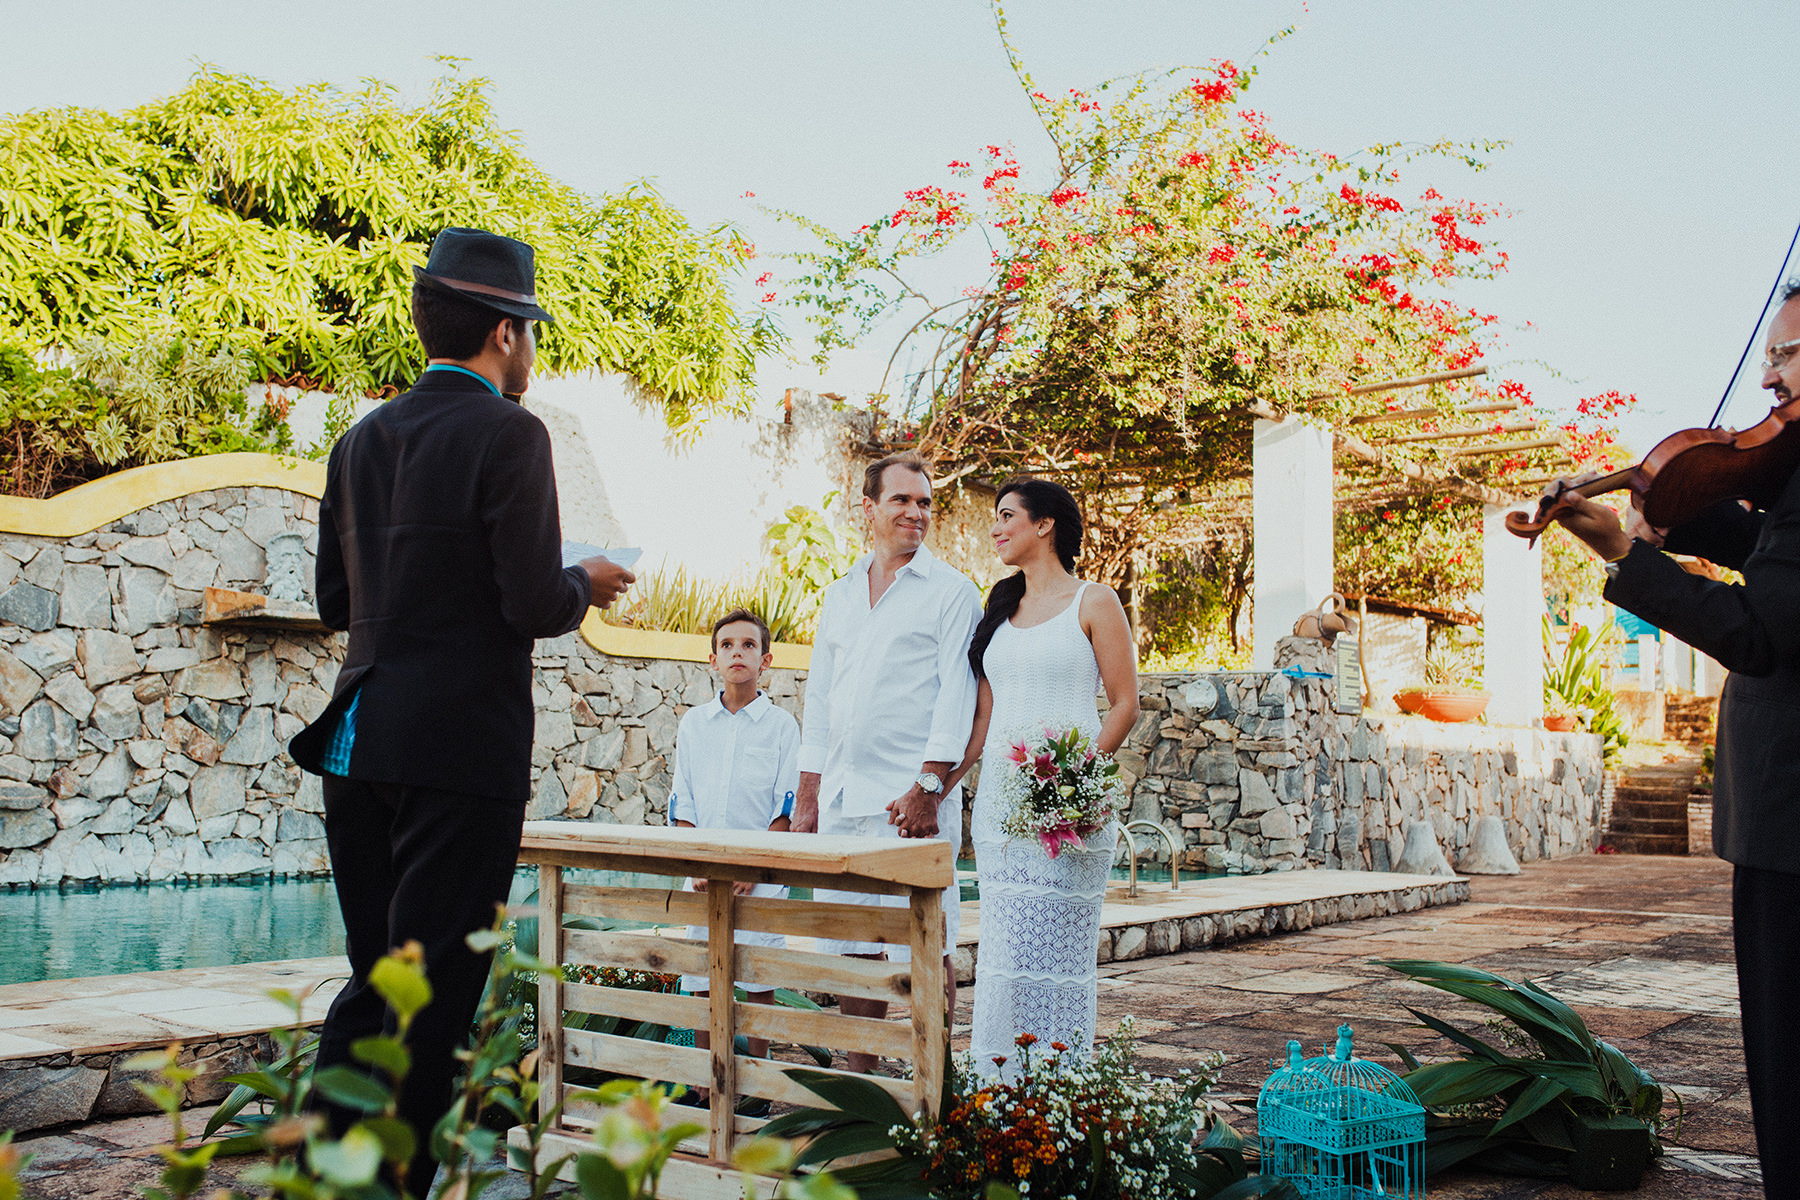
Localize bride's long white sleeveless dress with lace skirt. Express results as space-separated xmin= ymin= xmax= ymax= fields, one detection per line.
xmin=970 ymin=583 xmax=1118 ymax=1074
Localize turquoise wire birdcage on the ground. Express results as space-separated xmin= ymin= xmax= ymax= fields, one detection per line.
xmin=1256 ymin=1025 xmax=1426 ymax=1200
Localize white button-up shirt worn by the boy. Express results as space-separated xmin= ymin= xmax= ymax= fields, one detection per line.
xmin=670 ymin=693 xmax=799 ymax=829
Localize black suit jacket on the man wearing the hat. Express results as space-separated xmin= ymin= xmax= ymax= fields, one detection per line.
xmin=290 ymin=371 xmax=589 ymax=801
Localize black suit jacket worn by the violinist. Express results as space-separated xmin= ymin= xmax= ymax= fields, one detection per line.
xmin=1606 ymin=473 xmax=1800 ymax=874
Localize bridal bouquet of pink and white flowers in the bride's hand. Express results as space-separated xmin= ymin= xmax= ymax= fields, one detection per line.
xmin=1001 ymin=727 xmax=1125 ymax=858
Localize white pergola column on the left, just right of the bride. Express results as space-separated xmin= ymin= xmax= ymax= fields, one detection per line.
xmin=1251 ymin=417 xmax=1332 ymax=671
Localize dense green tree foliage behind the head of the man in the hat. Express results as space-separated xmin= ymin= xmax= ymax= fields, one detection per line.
xmin=0 ymin=68 xmax=781 ymax=426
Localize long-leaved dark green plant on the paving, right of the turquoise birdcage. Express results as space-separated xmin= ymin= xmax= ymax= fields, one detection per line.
xmin=1375 ymin=959 xmax=1663 ymax=1177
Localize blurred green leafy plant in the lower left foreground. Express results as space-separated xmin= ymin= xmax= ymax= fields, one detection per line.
xmin=126 ymin=925 xmax=857 ymax=1200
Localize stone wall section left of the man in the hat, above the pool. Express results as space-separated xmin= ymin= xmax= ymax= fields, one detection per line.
xmin=0 ymin=488 xmax=342 ymax=885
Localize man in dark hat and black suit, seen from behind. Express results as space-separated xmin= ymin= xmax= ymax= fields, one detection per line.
xmin=292 ymin=228 xmax=632 ymax=1196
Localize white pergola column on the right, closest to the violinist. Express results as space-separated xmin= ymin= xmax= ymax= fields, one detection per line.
xmin=1481 ymin=504 xmax=1544 ymax=725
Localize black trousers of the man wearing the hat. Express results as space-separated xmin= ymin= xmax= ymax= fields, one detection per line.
xmin=319 ymin=775 xmax=526 ymax=1196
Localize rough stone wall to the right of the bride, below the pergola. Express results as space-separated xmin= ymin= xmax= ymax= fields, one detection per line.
xmin=1118 ymin=639 xmax=1604 ymax=873
